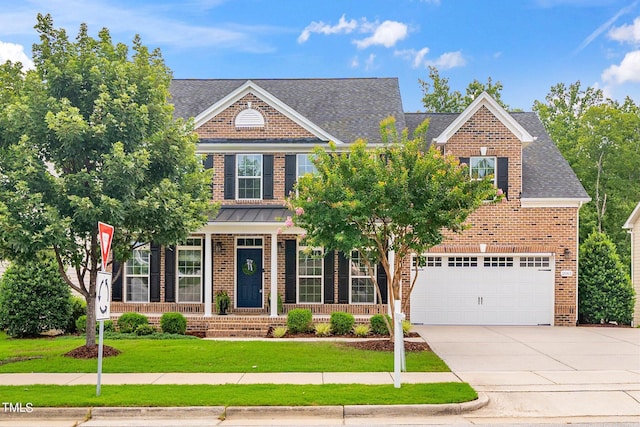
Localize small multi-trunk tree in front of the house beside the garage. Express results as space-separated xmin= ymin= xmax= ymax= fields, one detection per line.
xmin=288 ymin=118 xmax=499 ymax=332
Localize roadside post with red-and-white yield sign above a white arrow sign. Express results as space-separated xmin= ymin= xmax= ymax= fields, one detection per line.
xmin=95 ymin=222 xmax=113 ymax=396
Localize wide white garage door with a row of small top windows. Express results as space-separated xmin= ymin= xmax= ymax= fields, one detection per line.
xmin=411 ymin=255 xmax=554 ymax=325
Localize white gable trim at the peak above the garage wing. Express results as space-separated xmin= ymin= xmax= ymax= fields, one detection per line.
xmin=434 ymin=92 xmax=534 ymax=144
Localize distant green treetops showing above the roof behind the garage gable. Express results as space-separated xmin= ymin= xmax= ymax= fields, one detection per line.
xmin=418 ymin=66 xmax=509 ymax=113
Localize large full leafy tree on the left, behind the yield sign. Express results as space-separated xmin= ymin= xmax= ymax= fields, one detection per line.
xmin=0 ymin=15 xmax=212 ymax=347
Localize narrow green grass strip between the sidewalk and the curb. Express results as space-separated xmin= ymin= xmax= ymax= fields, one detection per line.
xmin=0 ymin=383 xmax=477 ymax=408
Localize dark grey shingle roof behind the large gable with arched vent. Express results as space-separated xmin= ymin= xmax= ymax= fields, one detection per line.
xmin=170 ymin=78 xmax=406 ymax=143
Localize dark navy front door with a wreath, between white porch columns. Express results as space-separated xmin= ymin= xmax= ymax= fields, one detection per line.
xmin=236 ymin=248 xmax=262 ymax=308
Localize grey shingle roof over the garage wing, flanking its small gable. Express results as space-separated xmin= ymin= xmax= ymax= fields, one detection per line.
xmin=405 ymin=113 xmax=589 ymax=199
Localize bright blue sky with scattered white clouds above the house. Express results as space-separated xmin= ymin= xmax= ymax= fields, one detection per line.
xmin=0 ymin=0 xmax=640 ymax=111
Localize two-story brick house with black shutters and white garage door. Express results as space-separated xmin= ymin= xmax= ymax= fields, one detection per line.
xmin=111 ymin=78 xmax=589 ymax=329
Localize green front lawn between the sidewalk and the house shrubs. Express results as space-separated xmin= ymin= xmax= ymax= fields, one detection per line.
xmin=0 ymin=333 xmax=449 ymax=373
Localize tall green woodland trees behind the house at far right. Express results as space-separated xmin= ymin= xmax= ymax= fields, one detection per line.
xmin=534 ymin=82 xmax=640 ymax=268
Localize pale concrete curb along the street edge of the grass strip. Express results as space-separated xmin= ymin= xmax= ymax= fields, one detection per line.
xmin=0 ymin=393 xmax=489 ymax=420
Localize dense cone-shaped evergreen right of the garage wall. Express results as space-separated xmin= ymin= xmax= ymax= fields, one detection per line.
xmin=578 ymin=232 xmax=634 ymax=325
